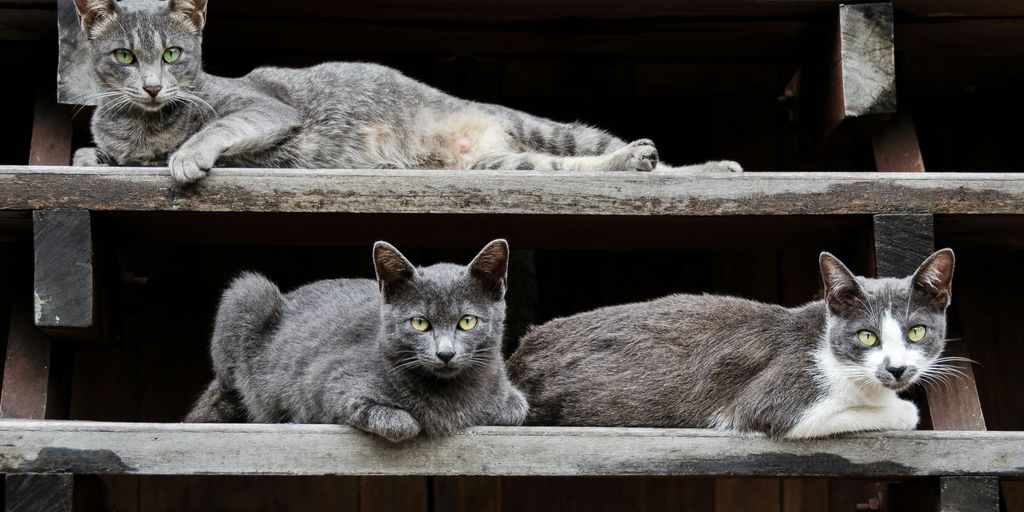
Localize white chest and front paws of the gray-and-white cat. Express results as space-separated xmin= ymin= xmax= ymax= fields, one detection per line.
xmin=785 ymin=347 xmax=919 ymax=439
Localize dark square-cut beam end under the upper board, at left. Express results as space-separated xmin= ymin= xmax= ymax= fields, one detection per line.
xmin=32 ymin=210 xmax=97 ymax=338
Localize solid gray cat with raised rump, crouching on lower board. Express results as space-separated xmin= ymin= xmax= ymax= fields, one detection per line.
xmin=185 ymin=240 xmax=527 ymax=441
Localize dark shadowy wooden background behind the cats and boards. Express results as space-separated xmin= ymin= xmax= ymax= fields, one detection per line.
xmin=0 ymin=0 xmax=1024 ymax=512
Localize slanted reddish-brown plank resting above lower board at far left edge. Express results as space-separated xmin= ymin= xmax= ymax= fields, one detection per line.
xmin=0 ymin=300 xmax=53 ymax=420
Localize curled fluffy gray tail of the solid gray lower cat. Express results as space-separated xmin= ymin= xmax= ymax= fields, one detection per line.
xmin=210 ymin=272 xmax=284 ymax=387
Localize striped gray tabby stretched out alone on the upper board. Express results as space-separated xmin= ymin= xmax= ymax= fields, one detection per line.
xmin=75 ymin=0 xmax=741 ymax=183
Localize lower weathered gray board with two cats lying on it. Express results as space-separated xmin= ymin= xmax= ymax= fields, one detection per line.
xmin=0 ymin=420 xmax=1024 ymax=478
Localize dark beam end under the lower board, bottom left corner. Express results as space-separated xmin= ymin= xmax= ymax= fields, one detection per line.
xmin=4 ymin=473 xmax=75 ymax=512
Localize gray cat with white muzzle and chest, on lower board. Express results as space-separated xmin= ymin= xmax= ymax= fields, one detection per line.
xmin=508 ymin=249 xmax=953 ymax=438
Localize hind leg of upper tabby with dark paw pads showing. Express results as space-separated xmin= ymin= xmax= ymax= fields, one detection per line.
xmin=469 ymin=139 xmax=658 ymax=172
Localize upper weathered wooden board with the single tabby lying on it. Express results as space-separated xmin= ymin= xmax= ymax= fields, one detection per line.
xmin=0 ymin=166 xmax=1024 ymax=216
